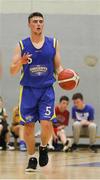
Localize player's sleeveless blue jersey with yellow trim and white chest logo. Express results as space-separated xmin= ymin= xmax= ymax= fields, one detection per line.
xmin=19 ymin=37 xmax=56 ymax=88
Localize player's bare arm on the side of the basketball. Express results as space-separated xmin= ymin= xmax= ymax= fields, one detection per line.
xmin=54 ymin=40 xmax=63 ymax=75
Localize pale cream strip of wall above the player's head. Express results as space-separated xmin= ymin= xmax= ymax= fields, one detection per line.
xmin=0 ymin=0 xmax=100 ymax=14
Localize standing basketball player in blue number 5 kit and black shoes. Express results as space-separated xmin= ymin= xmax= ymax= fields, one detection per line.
xmin=10 ymin=12 xmax=63 ymax=172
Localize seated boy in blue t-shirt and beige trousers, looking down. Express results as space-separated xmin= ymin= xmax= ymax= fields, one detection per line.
xmin=72 ymin=93 xmax=97 ymax=152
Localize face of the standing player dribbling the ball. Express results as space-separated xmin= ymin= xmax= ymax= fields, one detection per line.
xmin=29 ymin=16 xmax=44 ymax=35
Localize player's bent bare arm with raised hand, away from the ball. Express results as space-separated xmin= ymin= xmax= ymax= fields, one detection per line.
xmin=10 ymin=44 xmax=32 ymax=75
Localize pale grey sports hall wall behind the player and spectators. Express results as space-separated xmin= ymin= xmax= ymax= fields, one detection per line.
xmin=0 ymin=0 xmax=100 ymax=139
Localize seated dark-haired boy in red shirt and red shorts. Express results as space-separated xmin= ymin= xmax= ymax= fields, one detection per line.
xmin=48 ymin=96 xmax=71 ymax=151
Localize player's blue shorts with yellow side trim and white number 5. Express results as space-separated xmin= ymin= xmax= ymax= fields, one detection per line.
xmin=19 ymin=86 xmax=55 ymax=125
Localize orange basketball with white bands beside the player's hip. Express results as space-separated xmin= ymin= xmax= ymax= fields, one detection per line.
xmin=58 ymin=69 xmax=80 ymax=90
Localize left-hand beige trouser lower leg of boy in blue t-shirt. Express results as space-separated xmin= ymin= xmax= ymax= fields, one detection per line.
xmin=73 ymin=121 xmax=82 ymax=144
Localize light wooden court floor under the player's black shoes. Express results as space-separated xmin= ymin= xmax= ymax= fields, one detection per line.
xmin=0 ymin=150 xmax=100 ymax=180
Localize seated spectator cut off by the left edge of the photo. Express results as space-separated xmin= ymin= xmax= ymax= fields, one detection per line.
xmin=0 ymin=96 xmax=14 ymax=150
